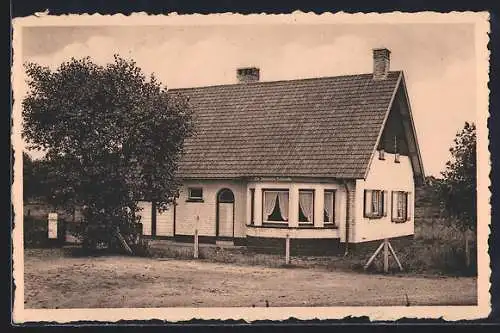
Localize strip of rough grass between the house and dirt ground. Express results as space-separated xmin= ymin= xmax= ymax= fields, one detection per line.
xmin=145 ymin=214 xmax=477 ymax=276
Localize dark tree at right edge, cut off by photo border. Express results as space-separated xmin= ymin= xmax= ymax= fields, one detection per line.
xmin=436 ymin=122 xmax=477 ymax=229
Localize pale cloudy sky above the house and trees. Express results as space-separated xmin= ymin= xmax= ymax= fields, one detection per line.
xmin=22 ymin=23 xmax=477 ymax=176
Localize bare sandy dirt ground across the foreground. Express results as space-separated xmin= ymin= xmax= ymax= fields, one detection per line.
xmin=25 ymin=248 xmax=477 ymax=308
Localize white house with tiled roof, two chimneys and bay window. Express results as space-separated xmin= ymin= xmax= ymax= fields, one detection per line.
xmin=141 ymin=49 xmax=424 ymax=253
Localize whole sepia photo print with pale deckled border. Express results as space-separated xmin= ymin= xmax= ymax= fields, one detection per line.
xmin=12 ymin=13 xmax=491 ymax=322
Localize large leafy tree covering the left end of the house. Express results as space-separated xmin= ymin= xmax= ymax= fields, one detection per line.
xmin=22 ymin=56 xmax=193 ymax=250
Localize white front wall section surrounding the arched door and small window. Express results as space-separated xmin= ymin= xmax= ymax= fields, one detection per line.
xmin=175 ymin=180 xmax=246 ymax=237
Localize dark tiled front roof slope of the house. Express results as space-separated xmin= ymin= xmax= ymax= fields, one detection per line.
xmin=171 ymin=72 xmax=401 ymax=178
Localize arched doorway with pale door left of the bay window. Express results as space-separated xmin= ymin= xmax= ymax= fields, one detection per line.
xmin=215 ymin=188 xmax=234 ymax=239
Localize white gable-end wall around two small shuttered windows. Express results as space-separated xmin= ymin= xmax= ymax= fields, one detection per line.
xmin=350 ymin=153 xmax=415 ymax=243
